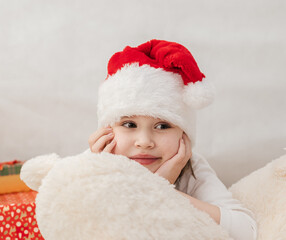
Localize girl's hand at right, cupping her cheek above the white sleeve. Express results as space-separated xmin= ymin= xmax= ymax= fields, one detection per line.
xmin=155 ymin=133 xmax=192 ymax=184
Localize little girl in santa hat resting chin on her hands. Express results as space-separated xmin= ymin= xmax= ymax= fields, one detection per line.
xmin=89 ymin=40 xmax=256 ymax=240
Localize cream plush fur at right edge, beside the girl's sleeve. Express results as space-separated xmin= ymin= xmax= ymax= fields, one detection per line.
xmin=229 ymin=155 xmax=286 ymax=240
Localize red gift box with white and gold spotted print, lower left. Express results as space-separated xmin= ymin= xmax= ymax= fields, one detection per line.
xmin=0 ymin=191 xmax=44 ymax=240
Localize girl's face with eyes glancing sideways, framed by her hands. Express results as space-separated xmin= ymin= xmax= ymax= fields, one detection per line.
xmin=113 ymin=116 xmax=183 ymax=173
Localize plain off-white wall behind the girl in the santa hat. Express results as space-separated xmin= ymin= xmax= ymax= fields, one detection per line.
xmin=0 ymin=0 xmax=286 ymax=186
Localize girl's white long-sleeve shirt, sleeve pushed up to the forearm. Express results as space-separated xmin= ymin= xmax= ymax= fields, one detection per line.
xmin=176 ymin=153 xmax=257 ymax=240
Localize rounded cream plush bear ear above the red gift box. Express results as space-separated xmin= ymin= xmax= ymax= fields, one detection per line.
xmin=20 ymin=153 xmax=60 ymax=191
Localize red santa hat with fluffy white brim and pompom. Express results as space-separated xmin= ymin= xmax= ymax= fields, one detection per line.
xmin=97 ymin=39 xmax=214 ymax=145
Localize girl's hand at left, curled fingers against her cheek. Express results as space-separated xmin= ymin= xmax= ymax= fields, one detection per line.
xmin=88 ymin=127 xmax=116 ymax=153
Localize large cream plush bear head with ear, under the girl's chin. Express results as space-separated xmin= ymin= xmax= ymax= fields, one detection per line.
xmin=21 ymin=152 xmax=230 ymax=240
